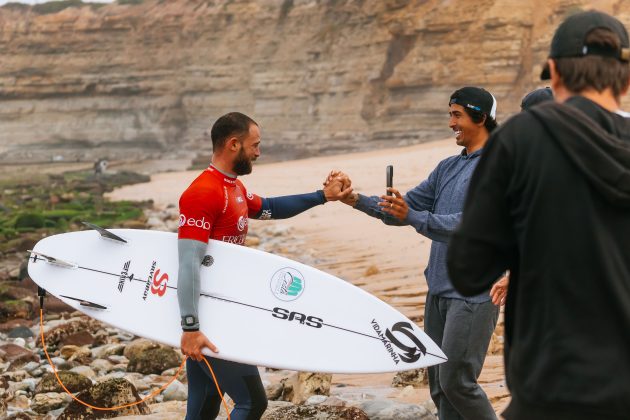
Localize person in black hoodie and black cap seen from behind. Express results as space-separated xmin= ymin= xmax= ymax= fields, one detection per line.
xmin=447 ymin=11 xmax=630 ymax=420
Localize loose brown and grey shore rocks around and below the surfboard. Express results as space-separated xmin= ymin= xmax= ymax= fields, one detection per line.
xmin=0 ymin=206 xmax=442 ymax=420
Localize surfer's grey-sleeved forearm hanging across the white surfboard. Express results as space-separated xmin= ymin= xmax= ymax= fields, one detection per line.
xmin=177 ymin=239 xmax=207 ymax=331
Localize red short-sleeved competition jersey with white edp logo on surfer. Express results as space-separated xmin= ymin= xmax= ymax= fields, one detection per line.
xmin=178 ymin=166 xmax=262 ymax=245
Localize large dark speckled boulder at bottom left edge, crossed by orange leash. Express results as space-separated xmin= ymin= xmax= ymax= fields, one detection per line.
xmin=57 ymin=378 xmax=151 ymax=420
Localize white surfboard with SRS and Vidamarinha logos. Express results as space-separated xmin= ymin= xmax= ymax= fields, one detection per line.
xmin=28 ymin=229 xmax=446 ymax=373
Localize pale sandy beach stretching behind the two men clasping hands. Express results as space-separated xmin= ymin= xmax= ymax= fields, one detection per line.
xmin=109 ymin=139 xmax=509 ymax=413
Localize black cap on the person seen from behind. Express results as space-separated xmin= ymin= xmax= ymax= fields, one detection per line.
xmin=540 ymin=10 xmax=630 ymax=80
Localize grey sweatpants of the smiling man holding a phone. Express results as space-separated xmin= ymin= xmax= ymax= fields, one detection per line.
xmin=424 ymin=294 xmax=499 ymax=420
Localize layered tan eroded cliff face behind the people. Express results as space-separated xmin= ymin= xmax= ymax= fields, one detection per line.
xmin=0 ymin=0 xmax=630 ymax=162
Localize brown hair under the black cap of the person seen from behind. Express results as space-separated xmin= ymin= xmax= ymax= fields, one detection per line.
xmin=553 ymin=28 xmax=630 ymax=98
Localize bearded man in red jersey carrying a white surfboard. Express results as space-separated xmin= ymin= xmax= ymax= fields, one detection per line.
xmin=177 ymin=112 xmax=352 ymax=420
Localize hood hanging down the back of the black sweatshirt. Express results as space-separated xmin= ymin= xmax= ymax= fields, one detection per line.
xmin=527 ymin=96 xmax=630 ymax=207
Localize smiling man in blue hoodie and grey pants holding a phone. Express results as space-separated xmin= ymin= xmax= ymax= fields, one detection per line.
xmin=331 ymin=87 xmax=498 ymax=420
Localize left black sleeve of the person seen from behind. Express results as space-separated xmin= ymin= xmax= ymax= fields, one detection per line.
xmin=447 ymin=133 xmax=516 ymax=296
